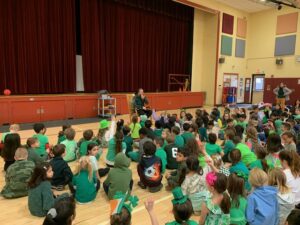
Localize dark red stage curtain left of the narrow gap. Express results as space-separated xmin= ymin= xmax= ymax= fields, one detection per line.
xmin=0 ymin=0 xmax=76 ymax=94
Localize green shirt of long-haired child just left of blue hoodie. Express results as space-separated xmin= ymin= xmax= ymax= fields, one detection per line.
xmin=230 ymin=196 xmax=247 ymax=225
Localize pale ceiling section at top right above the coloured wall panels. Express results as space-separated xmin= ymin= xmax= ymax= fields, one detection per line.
xmin=216 ymin=0 xmax=274 ymax=13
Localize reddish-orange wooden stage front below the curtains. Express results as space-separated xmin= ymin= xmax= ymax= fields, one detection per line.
xmin=0 ymin=92 xmax=205 ymax=125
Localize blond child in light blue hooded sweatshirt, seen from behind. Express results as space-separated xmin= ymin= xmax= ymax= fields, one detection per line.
xmin=246 ymin=168 xmax=279 ymax=225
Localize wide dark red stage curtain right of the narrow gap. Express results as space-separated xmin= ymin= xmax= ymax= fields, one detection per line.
xmin=80 ymin=0 xmax=194 ymax=92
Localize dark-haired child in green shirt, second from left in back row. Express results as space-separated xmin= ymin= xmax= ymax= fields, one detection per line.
xmin=33 ymin=123 xmax=49 ymax=157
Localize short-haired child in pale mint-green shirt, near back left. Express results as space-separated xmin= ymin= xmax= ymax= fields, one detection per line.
xmin=61 ymin=128 xmax=77 ymax=162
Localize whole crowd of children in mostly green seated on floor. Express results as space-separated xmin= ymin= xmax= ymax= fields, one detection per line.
xmin=1 ymin=99 xmax=300 ymax=225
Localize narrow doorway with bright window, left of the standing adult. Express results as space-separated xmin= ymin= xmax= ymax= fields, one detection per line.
xmin=251 ymin=74 xmax=265 ymax=104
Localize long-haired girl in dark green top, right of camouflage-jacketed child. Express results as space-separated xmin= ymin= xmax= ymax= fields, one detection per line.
xmin=28 ymin=163 xmax=69 ymax=217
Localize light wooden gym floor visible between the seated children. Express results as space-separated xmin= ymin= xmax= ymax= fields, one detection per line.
xmin=0 ymin=110 xmax=199 ymax=225
